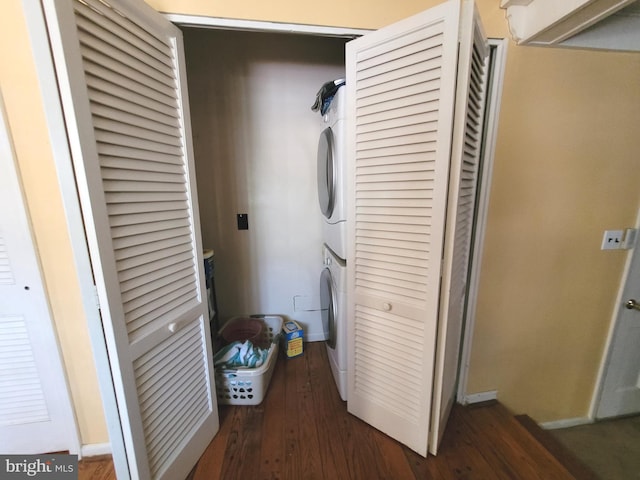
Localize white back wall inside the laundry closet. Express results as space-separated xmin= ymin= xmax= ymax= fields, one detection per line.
xmin=185 ymin=29 xmax=344 ymax=341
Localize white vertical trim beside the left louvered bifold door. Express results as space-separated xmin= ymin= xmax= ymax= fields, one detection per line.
xmin=22 ymin=0 xmax=129 ymax=470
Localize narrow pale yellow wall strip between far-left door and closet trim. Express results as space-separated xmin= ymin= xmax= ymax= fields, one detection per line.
xmin=0 ymin=0 xmax=108 ymax=444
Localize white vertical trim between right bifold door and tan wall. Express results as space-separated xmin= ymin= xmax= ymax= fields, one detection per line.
xmin=457 ymin=38 xmax=509 ymax=404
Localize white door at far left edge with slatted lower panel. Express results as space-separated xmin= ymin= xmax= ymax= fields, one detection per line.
xmin=0 ymin=96 xmax=79 ymax=455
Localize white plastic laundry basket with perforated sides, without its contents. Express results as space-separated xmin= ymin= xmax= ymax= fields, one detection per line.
xmin=214 ymin=315 xmax=282 ymax=405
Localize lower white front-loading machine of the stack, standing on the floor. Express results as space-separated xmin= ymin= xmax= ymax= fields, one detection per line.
xmin=320 ymin=245 xmax=347 ymax=400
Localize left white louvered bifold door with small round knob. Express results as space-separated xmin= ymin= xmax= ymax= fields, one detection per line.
xmin=44 ymin=0 xmax=218 ymax=480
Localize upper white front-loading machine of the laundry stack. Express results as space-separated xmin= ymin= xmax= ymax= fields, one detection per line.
xmin=318 ymin=86 xmax=347 ymax=260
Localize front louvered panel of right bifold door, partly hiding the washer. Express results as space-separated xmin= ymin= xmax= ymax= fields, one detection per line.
xmin=346 ymin=0 xmax=483 ymax=456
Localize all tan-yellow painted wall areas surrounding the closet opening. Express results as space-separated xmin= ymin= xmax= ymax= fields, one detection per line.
xmin=5 ymin=0 xmax=640 ymax=444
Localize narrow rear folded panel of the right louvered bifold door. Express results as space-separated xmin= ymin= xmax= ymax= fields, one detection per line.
xmin=429 ymin=1 xmax=489 ymax=455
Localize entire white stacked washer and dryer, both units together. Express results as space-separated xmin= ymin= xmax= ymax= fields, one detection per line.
xmin=318 ymin=80 xmax=347 ymax=400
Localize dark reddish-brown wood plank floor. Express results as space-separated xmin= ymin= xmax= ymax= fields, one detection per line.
xmin=79 ymin=343 xmax=593 ymax=480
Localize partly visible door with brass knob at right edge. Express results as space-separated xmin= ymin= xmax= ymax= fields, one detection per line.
xmin=596 ymin=231 xmax=640 ymax=418
